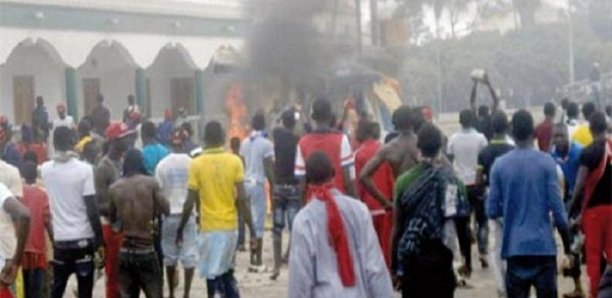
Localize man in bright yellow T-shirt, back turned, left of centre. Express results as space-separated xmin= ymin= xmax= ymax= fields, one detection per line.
xmin=176 ymin=121 xmax=255 ymax=297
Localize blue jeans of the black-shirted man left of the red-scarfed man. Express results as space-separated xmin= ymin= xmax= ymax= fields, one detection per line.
xmin=272 ymin=184 xmax=301 ymax=235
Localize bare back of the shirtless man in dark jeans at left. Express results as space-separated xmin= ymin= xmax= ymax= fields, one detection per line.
xmin=109 ymin=175 xmax=169 ymax=249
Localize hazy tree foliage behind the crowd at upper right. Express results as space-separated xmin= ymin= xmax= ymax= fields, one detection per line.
xmin=389 ymin=24 xmax=612 ymax=111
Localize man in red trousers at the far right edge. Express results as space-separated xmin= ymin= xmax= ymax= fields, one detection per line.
xmin=571 ymin=111 xmax=612 ymax=297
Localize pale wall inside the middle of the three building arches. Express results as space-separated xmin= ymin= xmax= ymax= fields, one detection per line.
xmin=77 ymin=47 xmax=136 ymax=120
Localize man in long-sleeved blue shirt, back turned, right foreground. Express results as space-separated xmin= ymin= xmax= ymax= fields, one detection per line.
xmin=486 ymin=110 xmax=570 ymax=298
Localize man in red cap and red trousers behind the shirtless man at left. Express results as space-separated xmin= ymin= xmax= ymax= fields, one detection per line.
xmin=95 ymin=122 xmax=133 ymax=298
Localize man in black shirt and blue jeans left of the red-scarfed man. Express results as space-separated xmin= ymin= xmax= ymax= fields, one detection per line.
xmin=270 ymin=109 xmax=301 ymax=280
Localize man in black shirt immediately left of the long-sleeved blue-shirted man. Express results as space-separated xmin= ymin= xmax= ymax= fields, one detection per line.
xmin=476 ymin=111 xmax=514 ymax=296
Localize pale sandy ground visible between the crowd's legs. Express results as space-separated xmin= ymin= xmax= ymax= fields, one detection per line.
xmin=76 ymin=232 xmax=586 ymax=298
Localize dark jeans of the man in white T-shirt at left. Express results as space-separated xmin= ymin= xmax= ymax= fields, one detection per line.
xmin=51 ymin=240 xmax=94 ymax=298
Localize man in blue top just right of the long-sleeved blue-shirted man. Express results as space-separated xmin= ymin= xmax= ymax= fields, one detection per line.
xmin=550 ymin=123 xmax=584 ymax=298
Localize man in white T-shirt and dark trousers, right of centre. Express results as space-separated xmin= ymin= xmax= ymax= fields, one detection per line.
xmin=446 ymin=110 xmax=489 ymax=276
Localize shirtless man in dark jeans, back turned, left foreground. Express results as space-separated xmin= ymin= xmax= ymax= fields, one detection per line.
xmin=109 ymin=149 xmax=170 ymax=298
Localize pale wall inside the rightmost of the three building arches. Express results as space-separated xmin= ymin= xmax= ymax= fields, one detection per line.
xmin=147 ymin=49 xmax=195 ymax=118
